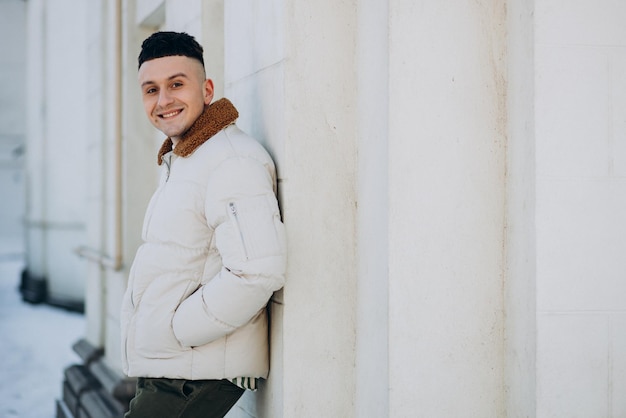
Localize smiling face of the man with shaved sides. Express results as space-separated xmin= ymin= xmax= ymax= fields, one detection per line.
xmin=139 ymin=56 xmax=213 ymax=144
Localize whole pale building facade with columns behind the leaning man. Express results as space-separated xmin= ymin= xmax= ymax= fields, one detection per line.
xmin=0 ymin=0 xmax=626 ymax=418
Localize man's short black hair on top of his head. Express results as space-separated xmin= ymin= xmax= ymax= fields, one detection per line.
xmin=137 ymin=32 xmax=204 ymax=68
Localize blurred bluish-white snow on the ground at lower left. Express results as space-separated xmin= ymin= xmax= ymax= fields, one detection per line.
xmin=0 ymin=256 xmax=85 ymax=418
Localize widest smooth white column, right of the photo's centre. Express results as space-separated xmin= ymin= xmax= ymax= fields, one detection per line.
xmin=389 ymin=0 xmax=507 ymax=418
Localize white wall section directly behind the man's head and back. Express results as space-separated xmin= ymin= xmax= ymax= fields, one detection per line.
xmin=222 ymin=0 xmax=289 ymax=418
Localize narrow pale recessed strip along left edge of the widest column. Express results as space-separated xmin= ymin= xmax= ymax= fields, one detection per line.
xmin=355 ymin=1 xmax=390 ymax=417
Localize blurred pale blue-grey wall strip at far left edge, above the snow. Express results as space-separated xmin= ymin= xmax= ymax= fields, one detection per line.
xmin=0 ymin=0 xmax=26 ymax=256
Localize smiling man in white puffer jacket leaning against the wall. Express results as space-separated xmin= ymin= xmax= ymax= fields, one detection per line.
xmin=121 ymin=32 xmax=285 ymax=418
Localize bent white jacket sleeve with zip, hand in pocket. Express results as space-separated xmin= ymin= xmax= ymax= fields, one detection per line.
xmin=172 ymin=153 xmax=286 ymax=347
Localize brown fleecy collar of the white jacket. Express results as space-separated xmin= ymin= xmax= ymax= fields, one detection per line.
xmin=158 ymin=98 xmax=239 ymax=165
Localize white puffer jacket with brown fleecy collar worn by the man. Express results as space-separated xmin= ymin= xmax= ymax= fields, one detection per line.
xmin=121 ymin=99 xmax=286 ymax=380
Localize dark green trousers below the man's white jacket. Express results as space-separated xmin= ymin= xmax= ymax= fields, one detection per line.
xmin=124 ymin=377 xmax=244 ymax=418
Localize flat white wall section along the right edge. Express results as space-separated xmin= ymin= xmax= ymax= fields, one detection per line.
xmin=535 ymin=0 xmax=626 ymax=418
